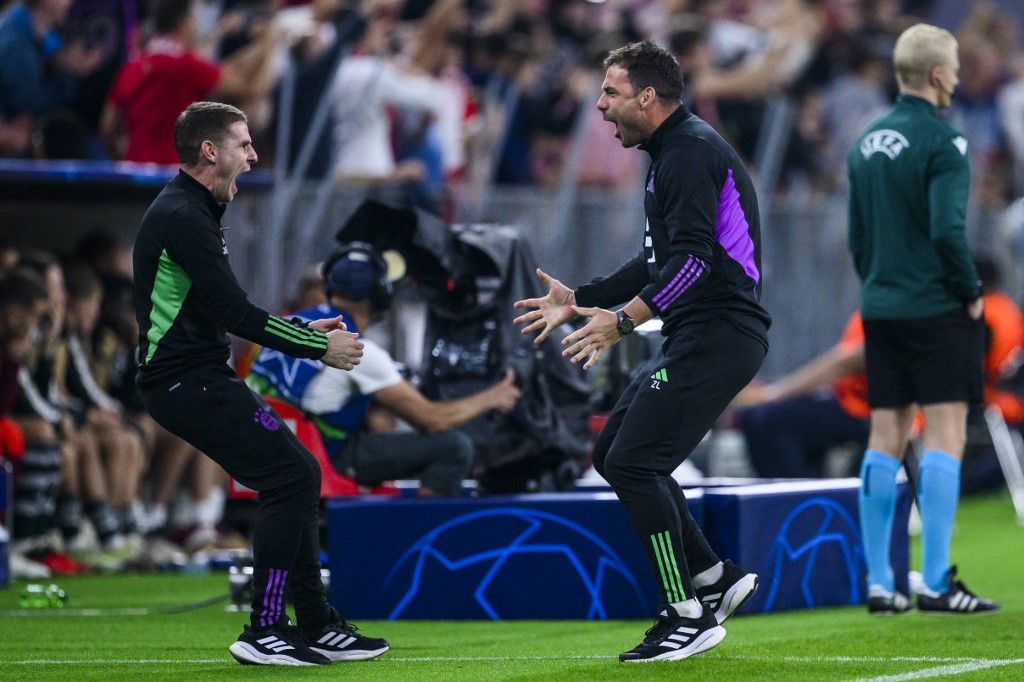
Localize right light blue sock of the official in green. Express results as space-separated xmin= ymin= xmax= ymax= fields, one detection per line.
xmin=918 ymin=450 xmax=959 ymax=592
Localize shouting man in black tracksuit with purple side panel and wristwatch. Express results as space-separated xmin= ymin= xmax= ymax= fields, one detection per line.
xmin=515 ymin=42 xmax=770 ymax=662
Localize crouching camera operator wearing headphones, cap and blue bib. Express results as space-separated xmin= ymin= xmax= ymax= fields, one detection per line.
xmin=247 ymin=243 xmax=520 ymax=496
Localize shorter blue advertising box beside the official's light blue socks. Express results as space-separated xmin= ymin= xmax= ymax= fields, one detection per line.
xmin=703 ymin=478 xmax=910 ymax=613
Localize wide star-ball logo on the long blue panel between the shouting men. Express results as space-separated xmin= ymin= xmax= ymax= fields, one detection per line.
xmin=384 ymin=507 xmax=648 ymax=621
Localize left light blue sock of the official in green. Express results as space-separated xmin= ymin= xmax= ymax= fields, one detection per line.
xmin=857 ymin=450 xmax=900 ymax=592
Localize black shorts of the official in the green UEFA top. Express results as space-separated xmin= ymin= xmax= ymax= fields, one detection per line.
xmin=864 ymin=308 xmax=985 ymax=408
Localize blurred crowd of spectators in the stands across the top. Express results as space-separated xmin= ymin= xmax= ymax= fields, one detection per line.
xmin=0 ymin=0 xmax=1024 ymax=200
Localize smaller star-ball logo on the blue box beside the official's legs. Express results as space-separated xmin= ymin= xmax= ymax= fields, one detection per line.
xmin=761 ymin=491 xmax=864 ymax=613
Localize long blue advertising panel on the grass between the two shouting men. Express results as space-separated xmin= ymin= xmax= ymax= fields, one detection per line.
xmin=327 ymin=491 xmax=701 ymax=620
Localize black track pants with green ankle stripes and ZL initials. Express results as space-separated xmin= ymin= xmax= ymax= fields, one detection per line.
xmin=594 ymin=319 xmax=766 ymax=603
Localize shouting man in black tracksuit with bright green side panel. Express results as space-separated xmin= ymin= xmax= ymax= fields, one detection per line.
xmin=134 ymin=102 xmax=388 ymax=666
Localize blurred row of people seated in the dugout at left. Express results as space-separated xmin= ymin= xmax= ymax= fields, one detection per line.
xmin=0 ymin=235 xmax=233 ymax=578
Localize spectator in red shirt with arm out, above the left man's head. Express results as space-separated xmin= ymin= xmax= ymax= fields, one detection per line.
xmin=99 ymin=0 xmax=272 ymax=164
